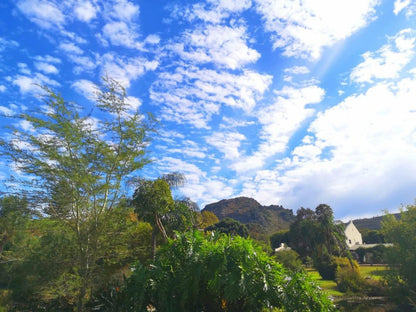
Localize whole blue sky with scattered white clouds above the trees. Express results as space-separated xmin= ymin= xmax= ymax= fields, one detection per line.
xmin=0 ymin=0 xmax=416 ymax=220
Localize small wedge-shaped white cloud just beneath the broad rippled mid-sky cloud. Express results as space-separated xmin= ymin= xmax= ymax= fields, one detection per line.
xmin=205 ymin=132 xmax=246 ymax=160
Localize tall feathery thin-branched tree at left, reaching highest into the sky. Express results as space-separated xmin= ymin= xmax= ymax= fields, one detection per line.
xmin=0 ymin=77 xmax=153 ymax=311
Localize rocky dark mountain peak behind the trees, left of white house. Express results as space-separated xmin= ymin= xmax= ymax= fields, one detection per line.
xmin=203 ymin=197 xmax=295 ymax=233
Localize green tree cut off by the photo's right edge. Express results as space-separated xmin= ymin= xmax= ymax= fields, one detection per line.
xmin=382 ymin=204 xmax=416 ymax=311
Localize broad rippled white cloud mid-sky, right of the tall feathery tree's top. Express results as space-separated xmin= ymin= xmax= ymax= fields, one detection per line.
xmin=150 ymin=66 xmax=271 ymax=128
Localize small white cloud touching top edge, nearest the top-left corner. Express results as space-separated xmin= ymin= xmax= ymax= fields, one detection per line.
xmin=17 ymin=0 xmax=65 ymax=29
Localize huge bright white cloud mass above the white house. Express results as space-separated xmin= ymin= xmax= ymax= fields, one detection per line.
xmin=266 ymin=79 xmax=416 ymax=215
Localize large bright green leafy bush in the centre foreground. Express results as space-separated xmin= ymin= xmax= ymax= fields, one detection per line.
xmin=118 ymin=231 xmax=334 ymax=312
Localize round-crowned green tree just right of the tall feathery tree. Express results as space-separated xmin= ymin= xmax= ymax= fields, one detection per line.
xmin=131 ymin=173 xmax=185 ymax=258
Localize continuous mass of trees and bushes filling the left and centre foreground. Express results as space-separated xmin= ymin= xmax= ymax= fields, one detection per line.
xmin=0 ymin=78 xmax=333 ymax=312
